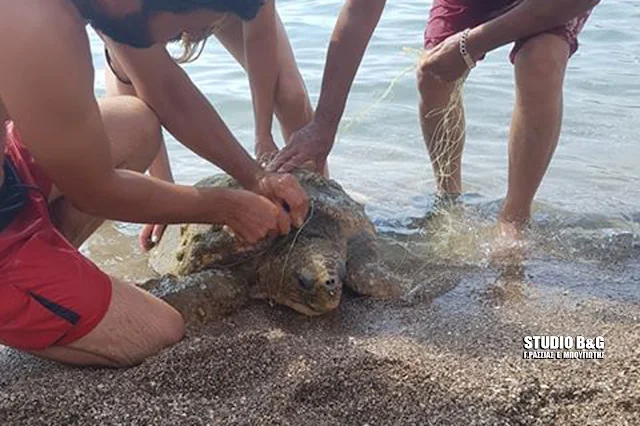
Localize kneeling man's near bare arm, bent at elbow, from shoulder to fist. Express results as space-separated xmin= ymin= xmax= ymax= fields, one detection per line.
xmin=0 ymin=7 xmax=279 ymax=241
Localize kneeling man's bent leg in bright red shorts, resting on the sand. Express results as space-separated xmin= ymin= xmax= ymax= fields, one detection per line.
xmin=0 ymin=226 xmax=184 ymax=366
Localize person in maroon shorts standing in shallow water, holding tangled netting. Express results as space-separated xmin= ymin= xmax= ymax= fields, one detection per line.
xmin=418 ymin=0 xmax=598 ymax=241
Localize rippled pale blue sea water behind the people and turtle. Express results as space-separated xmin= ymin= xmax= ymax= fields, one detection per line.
xmin=85 ymin=0 xmax=640 ymax=282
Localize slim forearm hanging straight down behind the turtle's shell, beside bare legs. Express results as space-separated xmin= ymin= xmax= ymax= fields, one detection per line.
xmin=242 ymin=0 xmax=278 ymax=158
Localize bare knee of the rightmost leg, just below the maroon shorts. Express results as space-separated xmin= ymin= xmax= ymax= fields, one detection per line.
xmin=515 ymin=34 xmax=569 ymax=84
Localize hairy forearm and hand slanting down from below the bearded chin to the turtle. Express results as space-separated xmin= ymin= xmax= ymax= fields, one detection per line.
xmin=107 ymin=39 xmax=308 ymax=226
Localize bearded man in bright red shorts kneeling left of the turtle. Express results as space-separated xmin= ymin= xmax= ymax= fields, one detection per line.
xmin=0 ymin=0 xmax=308 ymax=366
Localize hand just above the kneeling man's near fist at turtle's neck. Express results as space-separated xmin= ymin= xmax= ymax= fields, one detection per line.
xmin=254 ymin=173 xmax=309 ymax=230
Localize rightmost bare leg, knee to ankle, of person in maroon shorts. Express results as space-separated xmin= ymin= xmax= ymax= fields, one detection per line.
xmin=500 ymin=34 xmax=569 ymax=236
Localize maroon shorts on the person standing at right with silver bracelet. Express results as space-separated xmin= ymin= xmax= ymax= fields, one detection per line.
xmin=424 ymin=0 xmax=591 ymax=63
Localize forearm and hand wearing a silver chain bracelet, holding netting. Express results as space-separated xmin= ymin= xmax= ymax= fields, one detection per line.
xmin=422 ymin=0 xmax=599 ymax=81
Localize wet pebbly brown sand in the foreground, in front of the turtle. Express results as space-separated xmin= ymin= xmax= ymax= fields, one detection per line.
xmin=0 ymin=236 xmax=640 ymax=426
